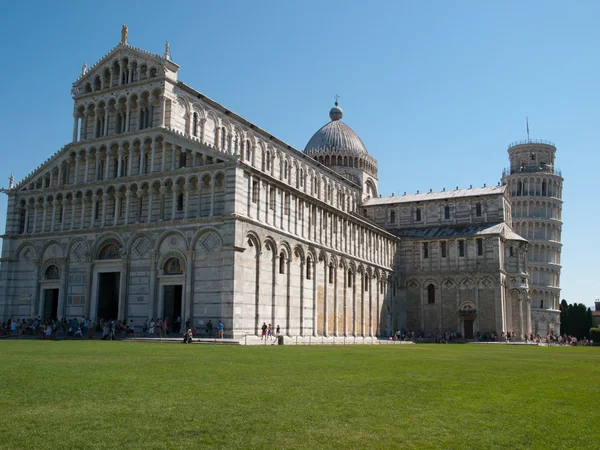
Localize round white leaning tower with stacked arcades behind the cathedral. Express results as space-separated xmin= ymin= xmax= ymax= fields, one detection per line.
xmin=502 ymin=139 xmax=563 ymax=336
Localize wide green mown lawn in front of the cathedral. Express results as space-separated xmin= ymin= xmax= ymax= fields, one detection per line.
xmin=0 ymin=341 xmax=600 ymax=450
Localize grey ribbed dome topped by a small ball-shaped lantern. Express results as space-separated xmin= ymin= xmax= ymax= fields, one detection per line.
xmin=304 ymin=102 xmax=369 ymax=156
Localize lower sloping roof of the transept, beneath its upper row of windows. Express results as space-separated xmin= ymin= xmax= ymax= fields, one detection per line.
xmin=389 ymin=222 xmax=527 ymax=242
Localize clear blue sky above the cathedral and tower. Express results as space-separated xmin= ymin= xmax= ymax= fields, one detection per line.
xmin=0 ymin=0 xmax=600 ymax=305
